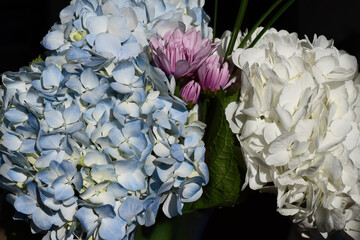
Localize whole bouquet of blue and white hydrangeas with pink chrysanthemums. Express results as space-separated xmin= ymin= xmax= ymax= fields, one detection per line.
xmin=0 ymin=0 xmax=360 ymax=240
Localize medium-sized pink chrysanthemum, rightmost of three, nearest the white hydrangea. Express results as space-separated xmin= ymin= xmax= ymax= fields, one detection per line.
xmin=198 ymin=55 xmax=235 ymax=92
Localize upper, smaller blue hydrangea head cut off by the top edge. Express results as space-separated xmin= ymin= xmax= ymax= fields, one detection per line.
xmin=42 ymin=0 xmax=212 ymax=57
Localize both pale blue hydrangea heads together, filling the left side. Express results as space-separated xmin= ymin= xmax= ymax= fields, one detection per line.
xmin=0 ymin=0 xmax=211 ymax=240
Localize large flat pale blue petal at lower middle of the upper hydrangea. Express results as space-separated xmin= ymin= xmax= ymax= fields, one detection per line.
xmin=95 ymin=33 xmax=121 ymax=58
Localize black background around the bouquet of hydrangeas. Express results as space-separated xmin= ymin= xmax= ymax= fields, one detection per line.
xmin=0 ymin=0 xmax=360 ymax=240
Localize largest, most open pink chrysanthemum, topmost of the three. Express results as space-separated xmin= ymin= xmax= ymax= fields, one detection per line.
xmin=150 ymin=29 xmax=217 ymax=78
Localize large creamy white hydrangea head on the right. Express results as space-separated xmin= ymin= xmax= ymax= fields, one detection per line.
xmin=226 ymin=29 xmax=360 ymax=237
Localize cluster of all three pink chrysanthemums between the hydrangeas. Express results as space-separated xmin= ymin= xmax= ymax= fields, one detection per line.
xmin=150 ymin=29 xmax=233 ymax=105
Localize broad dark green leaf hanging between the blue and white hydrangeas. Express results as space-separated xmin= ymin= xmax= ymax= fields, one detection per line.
xmin=185 ymin=91 xmax=241 ymax=210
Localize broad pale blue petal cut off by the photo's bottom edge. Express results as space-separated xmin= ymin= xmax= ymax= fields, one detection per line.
xmin=99 ymin=218 xmax=125 ymax=240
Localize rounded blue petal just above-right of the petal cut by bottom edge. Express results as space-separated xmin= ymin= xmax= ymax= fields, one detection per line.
xmin=119 ymin=196 xmax=144 ymax=222
